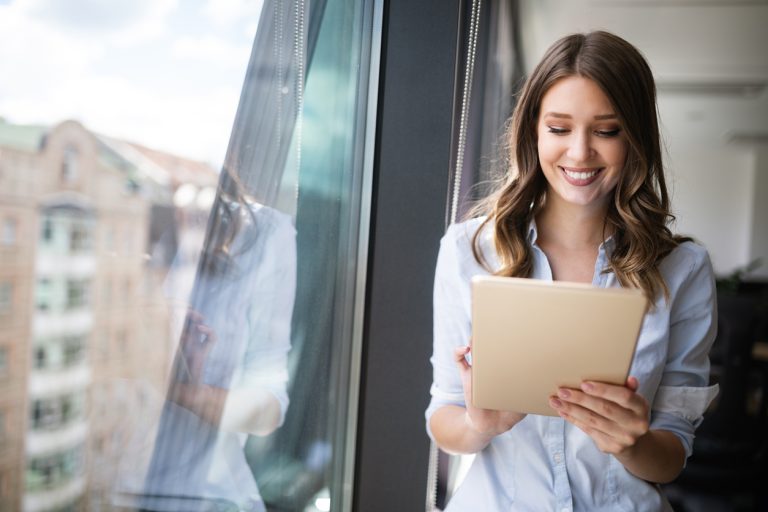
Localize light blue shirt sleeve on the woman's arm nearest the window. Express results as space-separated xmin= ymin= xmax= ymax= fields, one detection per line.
xmin=425 ymin=225 xmax=471 ymax=437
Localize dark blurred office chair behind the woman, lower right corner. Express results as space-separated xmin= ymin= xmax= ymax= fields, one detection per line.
xmin=668 ymin=293 xmax=768 ymax=511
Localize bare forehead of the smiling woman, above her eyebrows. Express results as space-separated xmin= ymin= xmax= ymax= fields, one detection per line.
xmin=540 ymin=76 xmax=615 ymax=117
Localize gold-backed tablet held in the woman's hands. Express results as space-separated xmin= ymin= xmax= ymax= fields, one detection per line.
xmin=471 ymin=276 xmax=646 ymax=416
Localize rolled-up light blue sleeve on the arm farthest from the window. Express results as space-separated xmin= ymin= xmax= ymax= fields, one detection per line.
xmin=651 ymin=243 xmax=718 ymax=457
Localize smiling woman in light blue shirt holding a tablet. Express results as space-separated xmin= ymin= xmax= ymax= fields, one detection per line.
xmin=427 ymin=32 xmax=716 ymax=511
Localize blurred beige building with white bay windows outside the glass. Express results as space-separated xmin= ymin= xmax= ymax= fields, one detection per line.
xmin=0 ymin=119 xmax=218 ymax=511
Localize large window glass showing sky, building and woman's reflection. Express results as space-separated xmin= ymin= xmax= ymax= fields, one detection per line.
xmin=0 ymin=0 xmax=375 ymax=511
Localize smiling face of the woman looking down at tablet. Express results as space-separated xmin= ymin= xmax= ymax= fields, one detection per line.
xmin=536 ymin=76 xmax=627 ymax=213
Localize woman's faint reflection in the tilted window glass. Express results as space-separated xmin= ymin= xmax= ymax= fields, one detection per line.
xmin=127 ymin=186 xmax=296 ymax=510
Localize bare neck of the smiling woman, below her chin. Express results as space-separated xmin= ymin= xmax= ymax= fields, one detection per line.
xmin=536 ymin=195 xmax=610 ymax=250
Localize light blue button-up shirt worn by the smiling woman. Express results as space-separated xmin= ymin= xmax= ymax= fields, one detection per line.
xmin=426 ymin=219 xmax=717 ymax=512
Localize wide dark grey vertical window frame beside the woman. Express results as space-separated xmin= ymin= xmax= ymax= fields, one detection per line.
xmin=352 ymin=0 xmax=463 ymax=512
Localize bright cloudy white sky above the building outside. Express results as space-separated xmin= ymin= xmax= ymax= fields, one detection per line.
xmin=0 ymin=0 xmax=263 ymax=168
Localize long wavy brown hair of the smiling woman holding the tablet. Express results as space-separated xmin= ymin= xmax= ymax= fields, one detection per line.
xmin=472 ymin=31 xmax=689 ymax=302
